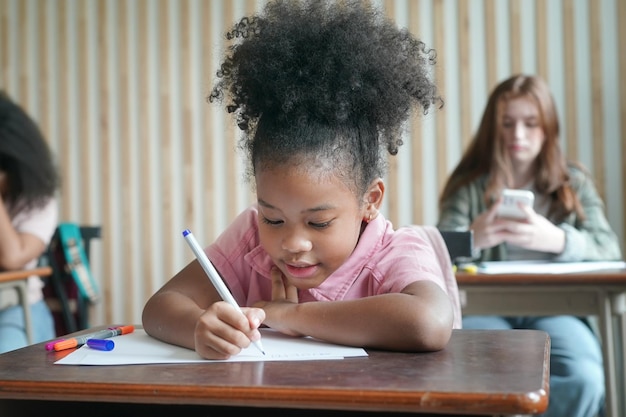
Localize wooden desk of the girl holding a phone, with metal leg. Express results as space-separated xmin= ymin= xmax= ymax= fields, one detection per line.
xmin=456 ymin=270 xmax=626 ymax=417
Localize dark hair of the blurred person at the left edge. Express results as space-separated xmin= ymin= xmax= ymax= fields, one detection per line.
xmin=0 ymin=91 xmax=59 ymax=210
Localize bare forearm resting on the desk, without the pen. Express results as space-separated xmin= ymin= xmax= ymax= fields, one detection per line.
xmin=261 ymin=281 xmax=454 ymax=352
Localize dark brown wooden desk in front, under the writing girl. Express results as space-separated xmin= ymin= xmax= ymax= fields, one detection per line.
xmin=0 ymin=329 xmax=550 ymax=417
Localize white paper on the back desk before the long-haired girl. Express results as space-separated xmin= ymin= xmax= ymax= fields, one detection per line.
xmin=478 ymin=261 xmax=626 ymax=274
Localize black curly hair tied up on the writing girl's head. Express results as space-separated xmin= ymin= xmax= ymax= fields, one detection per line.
xmin=209 ymin=0 xmax=443 ymax=192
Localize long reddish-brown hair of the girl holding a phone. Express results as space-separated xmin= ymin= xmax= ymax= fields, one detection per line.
xmin=439 ymin=74 xmax=584 ymax=220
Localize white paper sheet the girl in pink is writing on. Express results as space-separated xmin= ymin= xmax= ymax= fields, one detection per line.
xmin=55 ymin=328 xmax=367 ymax=365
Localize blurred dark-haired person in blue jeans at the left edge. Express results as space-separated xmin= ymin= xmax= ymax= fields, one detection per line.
xmin=0 ymin=91 xmax=58 ymax=352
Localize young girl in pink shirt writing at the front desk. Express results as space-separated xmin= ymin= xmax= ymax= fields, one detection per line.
xmin=143 ymin=1 xmax=460 ymax=359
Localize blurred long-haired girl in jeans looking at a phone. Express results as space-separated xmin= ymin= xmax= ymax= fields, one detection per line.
xmin=437 ymin=75 xmax=622 ymax=417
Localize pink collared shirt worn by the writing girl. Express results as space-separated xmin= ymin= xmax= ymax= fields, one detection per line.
xmin=205 ymin=206 xmax=461 ymax=328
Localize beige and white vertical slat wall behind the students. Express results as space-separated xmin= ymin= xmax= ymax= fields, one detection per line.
xmin=0 ymin=0 xmax=626 ymax=325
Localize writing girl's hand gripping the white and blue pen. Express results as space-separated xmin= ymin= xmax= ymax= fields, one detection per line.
xmin=194 ymin=301 xmax=265 ymax=359
